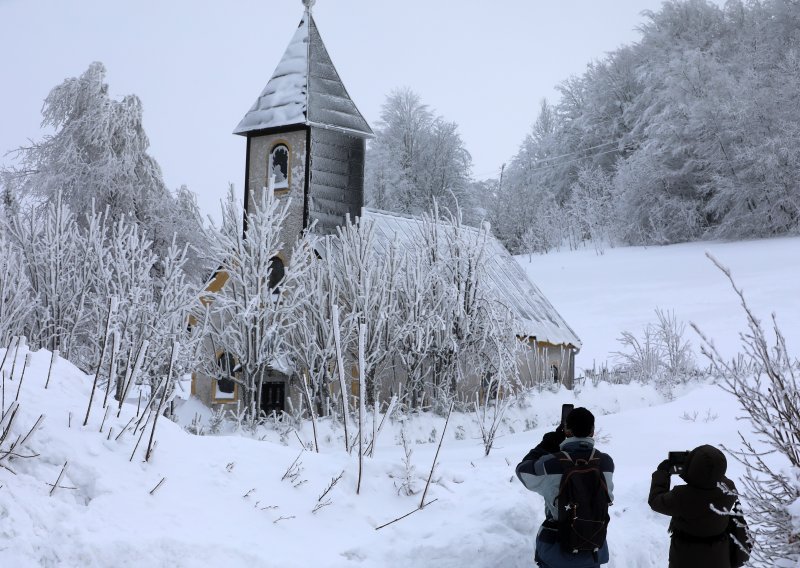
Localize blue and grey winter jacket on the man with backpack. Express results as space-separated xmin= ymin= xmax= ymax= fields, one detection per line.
xmin=517 ymin=437 xmax=614 ymax=568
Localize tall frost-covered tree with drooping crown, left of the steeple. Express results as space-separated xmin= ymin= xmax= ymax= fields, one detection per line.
xmin=1 ymin=63 xmax=209 ymax=280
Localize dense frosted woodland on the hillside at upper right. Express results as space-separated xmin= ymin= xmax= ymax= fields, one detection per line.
xmin=490 ymin=0 xmax=800 ymax=248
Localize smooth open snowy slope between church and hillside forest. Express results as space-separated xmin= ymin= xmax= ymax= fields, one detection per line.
xmin=518 ymin=237 xmax=800 ymax=368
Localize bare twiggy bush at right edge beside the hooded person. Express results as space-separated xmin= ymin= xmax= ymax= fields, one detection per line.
xmin=695 ymin=255 xmax=800 ymax=567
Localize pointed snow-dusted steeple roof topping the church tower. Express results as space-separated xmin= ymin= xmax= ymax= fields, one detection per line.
xmin=233 ymin=9 xmax=373 ymax=137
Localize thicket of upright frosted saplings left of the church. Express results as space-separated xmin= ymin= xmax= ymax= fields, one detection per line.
xmin=4 ymin=194 xmax=198 ymax=388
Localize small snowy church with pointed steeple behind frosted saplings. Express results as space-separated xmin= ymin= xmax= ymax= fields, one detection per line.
xmin=192 ymin=0 xmax=581 ymax=414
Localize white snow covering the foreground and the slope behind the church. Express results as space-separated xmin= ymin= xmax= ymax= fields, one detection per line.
xmin=0 ymin=234 xmax=800 ymax=568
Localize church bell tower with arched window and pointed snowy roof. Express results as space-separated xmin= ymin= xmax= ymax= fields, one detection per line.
xmin=234 ymin=0 xmax=373 ymax=245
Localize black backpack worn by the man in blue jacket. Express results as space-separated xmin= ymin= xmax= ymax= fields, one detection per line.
xmin=556 ymin=449 xmax=611 ymax=554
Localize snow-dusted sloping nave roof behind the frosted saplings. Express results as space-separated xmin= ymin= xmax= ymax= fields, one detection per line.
xmin=361 ymin=207 xmax=581 ymax=349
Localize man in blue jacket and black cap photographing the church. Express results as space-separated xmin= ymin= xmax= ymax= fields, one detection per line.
xmin=517 ymin=408 xmax=614 ymax=568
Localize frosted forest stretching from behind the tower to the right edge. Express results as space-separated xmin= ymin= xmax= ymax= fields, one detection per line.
xmin=367 ymin=0 xmax=800 ymax=253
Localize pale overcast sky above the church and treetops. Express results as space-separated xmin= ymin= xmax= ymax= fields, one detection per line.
xmin=0 ymin=0 xmax=684 ymax=216
